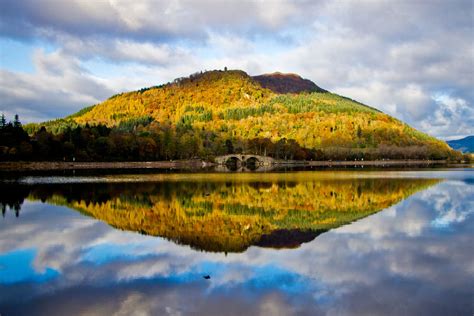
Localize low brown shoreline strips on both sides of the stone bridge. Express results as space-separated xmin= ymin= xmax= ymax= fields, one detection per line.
xmin=0 ymin=160 xmax=472 ymax=171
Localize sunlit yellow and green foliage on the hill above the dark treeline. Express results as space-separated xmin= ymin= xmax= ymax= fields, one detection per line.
xmin=71 ymin=71 xmax=450 ymax=157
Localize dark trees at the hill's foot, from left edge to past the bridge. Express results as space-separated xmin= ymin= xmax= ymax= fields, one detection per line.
xmin=0 ymin=117 xmax=317 ymax=161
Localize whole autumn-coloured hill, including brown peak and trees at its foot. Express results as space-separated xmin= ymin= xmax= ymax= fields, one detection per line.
xmin=7 ymin=70 xmax=459 ymax=160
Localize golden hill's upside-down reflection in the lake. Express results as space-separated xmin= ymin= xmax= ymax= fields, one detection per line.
xmin=17 ymin=173 xmax=439 ymax=252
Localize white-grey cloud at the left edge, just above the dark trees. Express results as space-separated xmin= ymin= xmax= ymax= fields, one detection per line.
xmin=0 ymin=49 xmax=112 ymax=121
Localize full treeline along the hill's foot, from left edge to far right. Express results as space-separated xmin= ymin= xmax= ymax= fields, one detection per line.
xmin=0 ymin=116 xmax=467 ymax=161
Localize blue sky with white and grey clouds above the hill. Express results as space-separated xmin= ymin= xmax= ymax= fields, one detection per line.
xmin=0 ymin=0 xmax=474 ymax=139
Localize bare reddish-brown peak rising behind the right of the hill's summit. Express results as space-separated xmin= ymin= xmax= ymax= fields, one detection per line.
xmin=252 ymin=72 xmax=327 ymax=93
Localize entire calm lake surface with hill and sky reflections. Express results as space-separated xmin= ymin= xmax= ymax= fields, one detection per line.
xmin=0 ymin=169 xmax=474 ymax=316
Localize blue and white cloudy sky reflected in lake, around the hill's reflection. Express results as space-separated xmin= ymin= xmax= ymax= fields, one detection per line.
xmin=0 ymin=171 xmax=474 ymax=315
